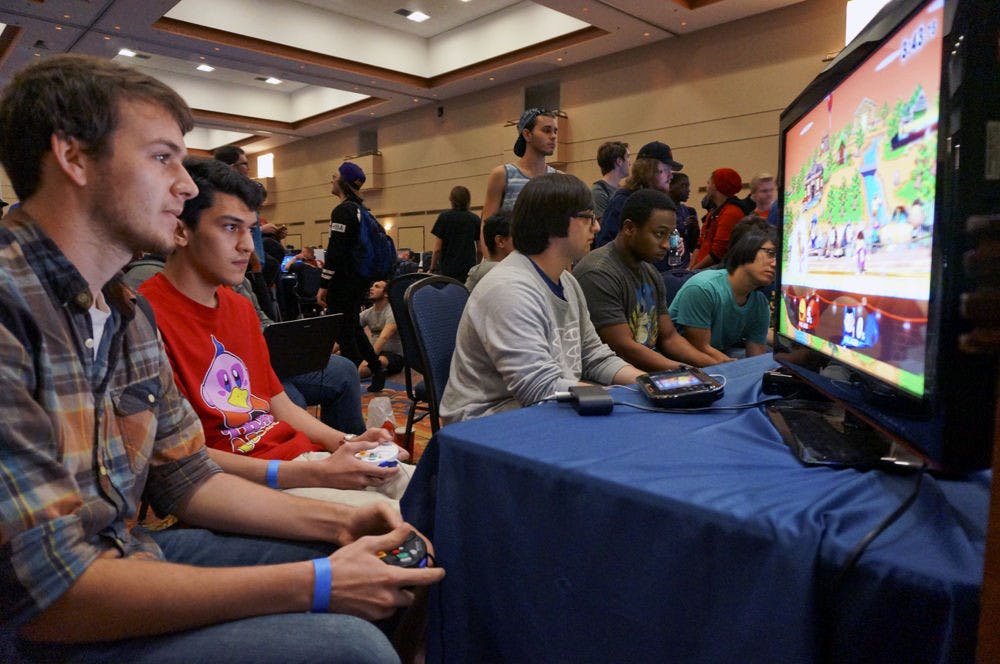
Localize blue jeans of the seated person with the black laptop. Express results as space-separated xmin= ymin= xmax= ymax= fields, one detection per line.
xmin=281 ymin=355 xmax=365 ymax=433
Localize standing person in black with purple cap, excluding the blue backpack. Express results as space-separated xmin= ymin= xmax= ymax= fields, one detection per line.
xmin=316 ymin=161 xmax=385 ymax=392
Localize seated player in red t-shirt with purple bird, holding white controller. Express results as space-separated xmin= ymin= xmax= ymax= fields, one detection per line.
xmin=139 ymin=160 xmax=412 ymax=503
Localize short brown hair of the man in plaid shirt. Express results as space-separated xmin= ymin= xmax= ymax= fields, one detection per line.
xmin=0 ymin=54 xmax=194 ymax=201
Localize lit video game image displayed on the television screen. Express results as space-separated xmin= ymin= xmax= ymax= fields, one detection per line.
xmin=778 ymin=0 xmax=944 ymax=397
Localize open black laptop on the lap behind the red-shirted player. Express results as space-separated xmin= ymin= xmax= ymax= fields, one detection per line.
xmin=264 ymin=314 xmax=343 ymax=380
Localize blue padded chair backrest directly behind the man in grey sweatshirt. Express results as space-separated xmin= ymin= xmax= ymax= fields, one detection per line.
xmin=406 ymin=276 xmax=469 ymax=425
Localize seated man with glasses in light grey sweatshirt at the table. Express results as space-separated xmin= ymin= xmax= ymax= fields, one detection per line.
xmin=441 ymin=173 xmax=642 ymax=423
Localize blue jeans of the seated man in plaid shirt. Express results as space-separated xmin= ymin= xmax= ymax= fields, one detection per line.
xmin=15 ymin=528 xmax=399 ymax=664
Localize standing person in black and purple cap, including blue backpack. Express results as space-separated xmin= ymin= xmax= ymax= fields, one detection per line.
xmin=316 ymin=161 xmax=396 ymax=392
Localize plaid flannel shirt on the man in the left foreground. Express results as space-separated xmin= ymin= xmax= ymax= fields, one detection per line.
xmin=0 ymin=209 xmax=220 ymax=632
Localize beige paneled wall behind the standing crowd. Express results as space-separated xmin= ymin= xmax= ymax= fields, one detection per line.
xmin=251 ymin=0 xmax=845 ymax=249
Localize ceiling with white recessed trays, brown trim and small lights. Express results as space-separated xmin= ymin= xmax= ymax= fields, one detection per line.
xmin=0 ymin=0 xmax=801 ymax=152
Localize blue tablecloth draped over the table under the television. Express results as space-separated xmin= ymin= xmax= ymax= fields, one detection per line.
xmin=403 ymin=356 xmax=991 ymax=664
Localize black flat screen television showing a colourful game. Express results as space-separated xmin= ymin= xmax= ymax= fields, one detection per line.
xmin=775 ymin=0 xmax=1000 ymax=472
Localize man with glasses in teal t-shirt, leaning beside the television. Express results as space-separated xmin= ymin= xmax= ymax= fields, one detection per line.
xmin=670 ymin=226 xmax=777 ymax=361
